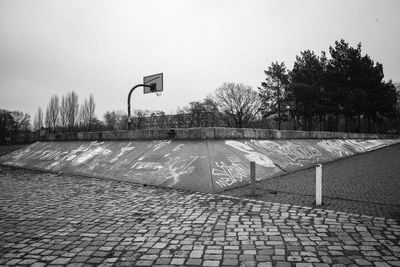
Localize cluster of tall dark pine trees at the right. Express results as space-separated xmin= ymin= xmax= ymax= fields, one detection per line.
xmin=258 ymin=40 xmax=399 ymax=132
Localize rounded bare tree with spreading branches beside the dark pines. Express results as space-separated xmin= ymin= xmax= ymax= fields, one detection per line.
xmin=215 ymin=83 xmax=261 ymax=128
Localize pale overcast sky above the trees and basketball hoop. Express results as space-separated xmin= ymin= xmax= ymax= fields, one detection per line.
xmin=0 ymin=0 xmax=400 ymax=119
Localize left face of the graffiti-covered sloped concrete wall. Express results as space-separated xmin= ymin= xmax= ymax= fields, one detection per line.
xmin=0 ymin=140 xmax=213 ymax=192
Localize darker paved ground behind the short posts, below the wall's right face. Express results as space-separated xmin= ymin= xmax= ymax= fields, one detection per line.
xmin=221 ymin=145 xmax=400 ymax=221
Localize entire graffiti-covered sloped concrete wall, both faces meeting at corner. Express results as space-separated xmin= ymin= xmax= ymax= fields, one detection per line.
xmin=0 ymin=139 xmax=400 ymax=192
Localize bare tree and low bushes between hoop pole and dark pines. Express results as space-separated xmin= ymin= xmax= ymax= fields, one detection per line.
xmin=126 ymin=83 xmax=261 ymax=129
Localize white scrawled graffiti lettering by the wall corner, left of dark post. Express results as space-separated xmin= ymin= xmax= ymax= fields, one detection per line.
xmin=211 ymin=161 xmax=250 ymax=188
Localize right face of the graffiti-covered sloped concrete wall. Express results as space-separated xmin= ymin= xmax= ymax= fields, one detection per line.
xmin=208 ymin=139 xmax=400 ymax=191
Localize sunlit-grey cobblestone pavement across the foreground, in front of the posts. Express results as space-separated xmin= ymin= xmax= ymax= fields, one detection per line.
xmin=0 ymin=167 xmax=400 ymax=267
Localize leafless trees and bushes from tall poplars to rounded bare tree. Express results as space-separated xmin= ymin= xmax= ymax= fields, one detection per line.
xmin=24 ymin=83 xmax=260 ymax=133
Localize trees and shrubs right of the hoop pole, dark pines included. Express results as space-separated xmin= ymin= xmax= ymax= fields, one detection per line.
xmin=136 ymin=39 xmax=400 ymax=133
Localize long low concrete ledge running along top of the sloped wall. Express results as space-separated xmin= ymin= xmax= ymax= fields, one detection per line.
xmin=41 ymin=127 xmax=400 ymax=141
